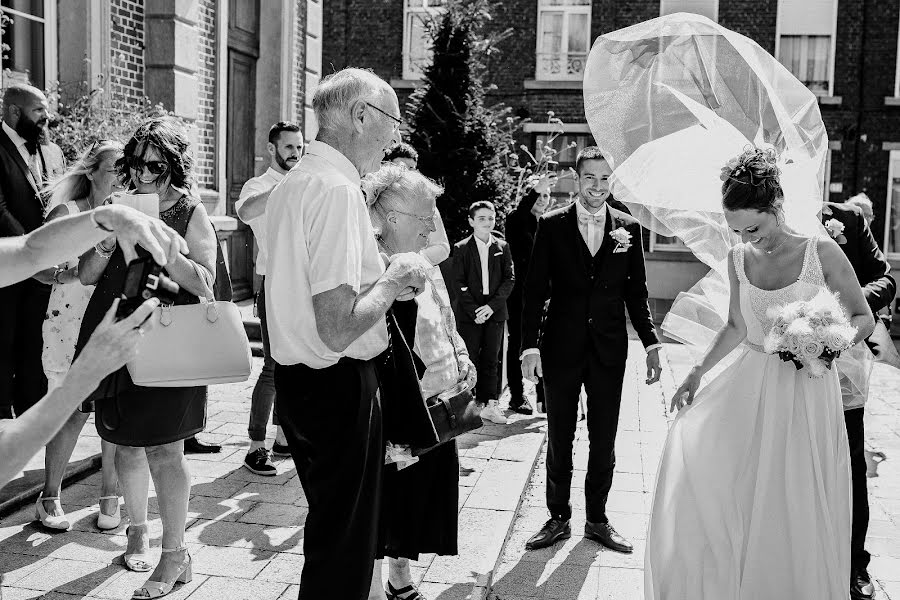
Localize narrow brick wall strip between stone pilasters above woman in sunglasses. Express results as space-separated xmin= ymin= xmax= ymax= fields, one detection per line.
xmin=109 ymin=0 xmax=144 ymax=101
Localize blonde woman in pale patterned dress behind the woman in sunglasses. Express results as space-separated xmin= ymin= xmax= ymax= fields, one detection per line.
xmin=35 ymin=140 xmax=122 ymax=531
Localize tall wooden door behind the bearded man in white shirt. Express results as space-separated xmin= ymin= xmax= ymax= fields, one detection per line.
xmin=225 ymin=0 xmax=259 ymax=301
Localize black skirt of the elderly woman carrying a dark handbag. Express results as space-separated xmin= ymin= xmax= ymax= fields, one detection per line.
xmin=379 ymin=300 xmax=459 ymax=560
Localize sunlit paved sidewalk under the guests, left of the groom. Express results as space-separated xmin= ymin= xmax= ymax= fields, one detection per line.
xmin=0 ymin=359 xmax=544 ymax=600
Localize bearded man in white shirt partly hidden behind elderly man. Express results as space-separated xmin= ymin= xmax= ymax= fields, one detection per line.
xmin=234 ymin=121 xmax=303 ymax=477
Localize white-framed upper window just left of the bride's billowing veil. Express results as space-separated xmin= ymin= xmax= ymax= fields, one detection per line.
xmin=535 ymin=0 xmax=591 ymax=81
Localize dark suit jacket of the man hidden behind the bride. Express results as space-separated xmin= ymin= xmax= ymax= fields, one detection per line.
xmin=822 ymin=202 xmax=897 ymax=322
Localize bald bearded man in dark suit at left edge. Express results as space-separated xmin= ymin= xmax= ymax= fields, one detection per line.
xmin=0 ymin=84 xmax=65 ymax=418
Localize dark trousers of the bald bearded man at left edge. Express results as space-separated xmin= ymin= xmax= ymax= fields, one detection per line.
xmin=0 ymin=279 xmax=50 ymax=418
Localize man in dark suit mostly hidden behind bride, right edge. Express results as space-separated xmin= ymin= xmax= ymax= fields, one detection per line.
xmin=822 ymin=201 xmax=897 ymax=600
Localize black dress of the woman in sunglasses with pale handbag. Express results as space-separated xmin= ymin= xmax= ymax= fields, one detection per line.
xmin=75 ymin=196 xmax=207 ymax=446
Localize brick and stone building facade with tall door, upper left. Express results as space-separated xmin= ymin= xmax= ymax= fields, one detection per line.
xmin=0 ymin=0 xmax=323 ymax=299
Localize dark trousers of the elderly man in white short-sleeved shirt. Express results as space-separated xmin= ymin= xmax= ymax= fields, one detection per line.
xmin=275 ymin=358 xmax=384 ymax=600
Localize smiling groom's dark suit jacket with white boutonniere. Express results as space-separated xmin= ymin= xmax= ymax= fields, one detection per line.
xmin=522 ymin=203 xmax=659 ymax=368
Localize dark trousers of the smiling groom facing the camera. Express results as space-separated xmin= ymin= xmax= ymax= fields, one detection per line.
xmin=544 ymin=352 xmax=625 ymax=523
